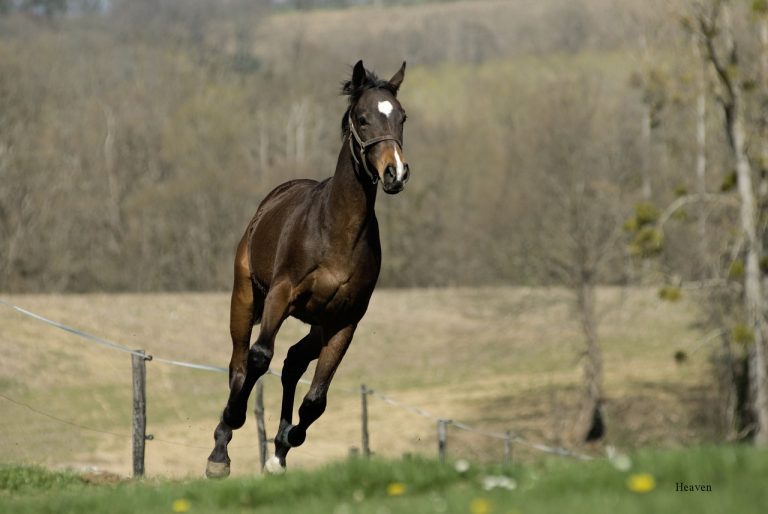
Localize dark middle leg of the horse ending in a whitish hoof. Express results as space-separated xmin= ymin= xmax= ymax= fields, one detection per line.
xmin=265 ymin=325 xmax=323 ymax=473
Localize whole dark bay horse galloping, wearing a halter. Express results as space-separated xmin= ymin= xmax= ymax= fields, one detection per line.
xmin=206 ymin=61 xmax=409 ymax=478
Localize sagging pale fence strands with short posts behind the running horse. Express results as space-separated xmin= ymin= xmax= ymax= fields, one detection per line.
xmin=0 ymin=299 xmax=591 ymax=474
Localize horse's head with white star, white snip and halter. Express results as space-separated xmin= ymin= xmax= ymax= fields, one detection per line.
xmin=341 ymin=61 xmax=410 ymax=194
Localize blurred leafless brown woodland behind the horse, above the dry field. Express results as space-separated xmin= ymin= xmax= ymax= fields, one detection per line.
xmin=0 ymin=0 xmax=660 ymax=291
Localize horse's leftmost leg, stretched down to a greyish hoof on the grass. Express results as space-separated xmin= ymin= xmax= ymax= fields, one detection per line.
xmin=205 ymin=282 xmax=291 ymax=478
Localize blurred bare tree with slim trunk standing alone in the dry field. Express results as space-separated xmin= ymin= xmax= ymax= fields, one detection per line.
xmin=528 ymin=77 xmax=627 ymax=442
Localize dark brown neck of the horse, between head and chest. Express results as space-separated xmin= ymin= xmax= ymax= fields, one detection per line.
xmin=329 ymin=139 xmax=377 ymax=239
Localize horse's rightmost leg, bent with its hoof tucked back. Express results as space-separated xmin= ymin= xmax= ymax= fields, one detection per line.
xmin=268 ymin=325 xmax=356 ymax=471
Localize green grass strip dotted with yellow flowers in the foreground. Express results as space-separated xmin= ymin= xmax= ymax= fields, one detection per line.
xmin=0 ymin=446 xmax=768 ymax=514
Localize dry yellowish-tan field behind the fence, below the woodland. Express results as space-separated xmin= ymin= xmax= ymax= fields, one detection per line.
xmin=0 ymin=288 xmax=715 ymax=477
